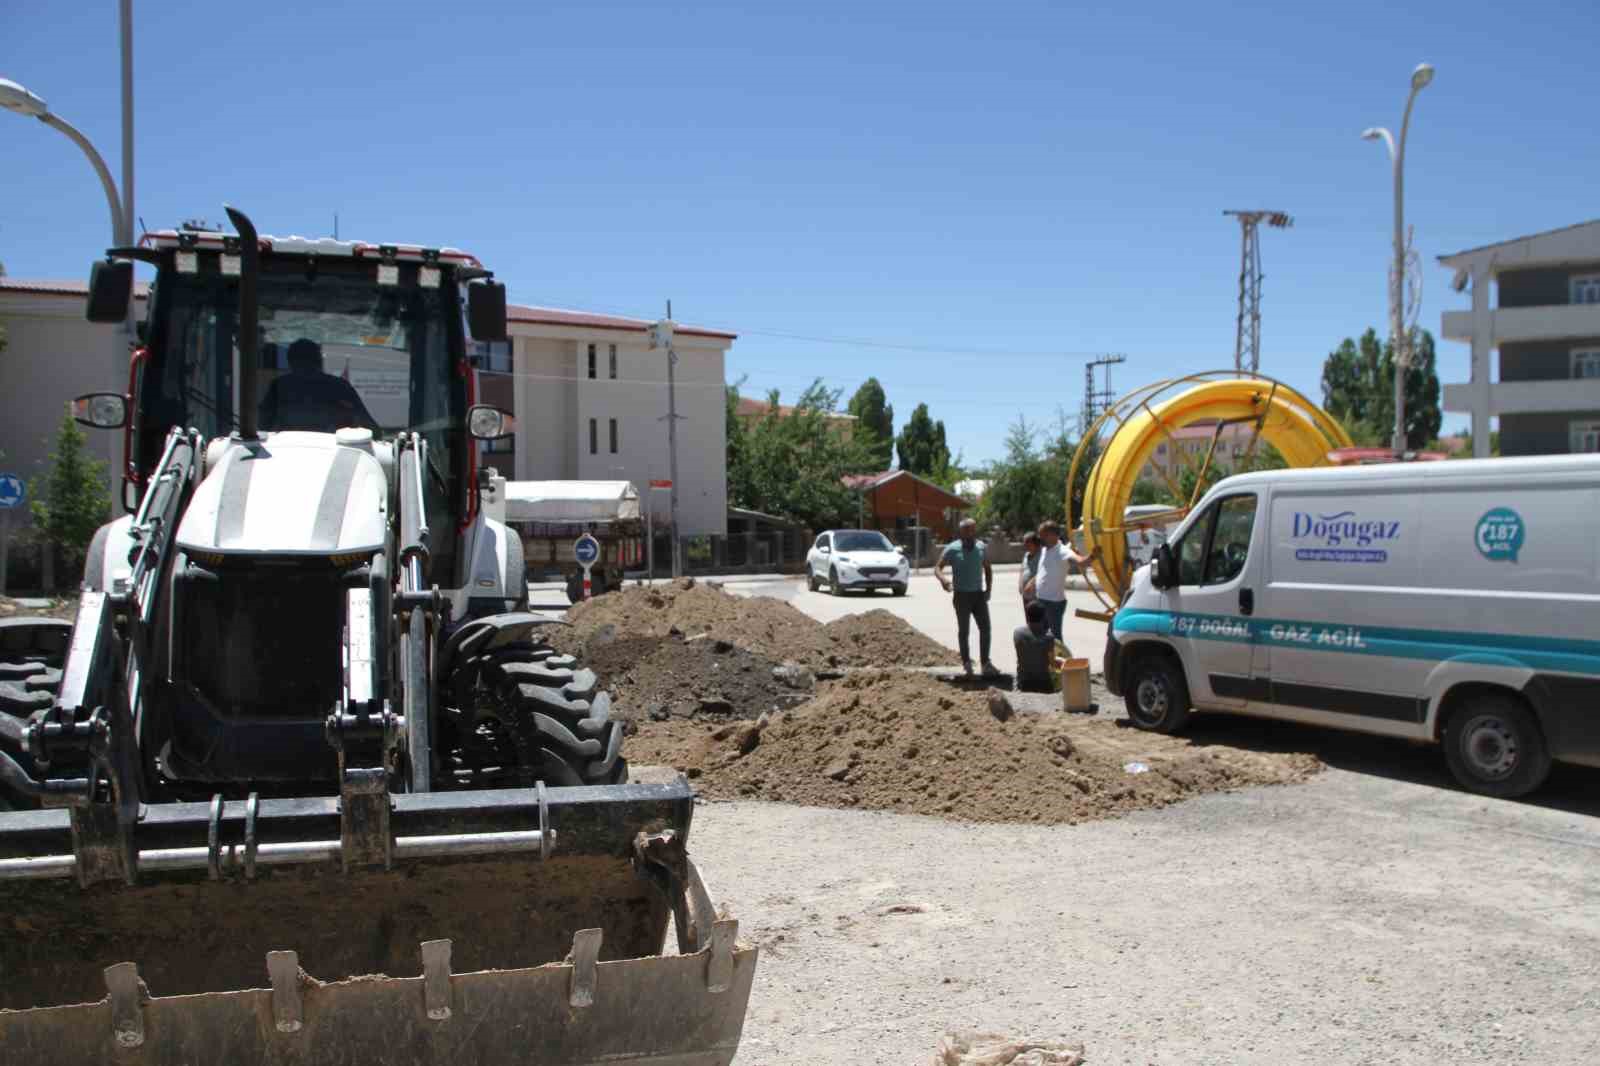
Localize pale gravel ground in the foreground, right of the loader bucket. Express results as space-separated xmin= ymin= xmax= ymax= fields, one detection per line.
xmin=691 ymin=745 xmax=1600 ymax=1066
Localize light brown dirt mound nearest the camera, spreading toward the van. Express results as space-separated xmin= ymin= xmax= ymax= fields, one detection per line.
xmin=629 ymin=671 xmax=1320 ymax=823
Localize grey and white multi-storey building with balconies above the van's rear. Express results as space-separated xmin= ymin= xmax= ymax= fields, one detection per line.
xmin=1438 ymin=221 xmax=1600 ymax=458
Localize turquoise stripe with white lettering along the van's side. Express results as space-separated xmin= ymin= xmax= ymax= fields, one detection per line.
xmin=1110 ymin=607 xmax=1600 ymax=675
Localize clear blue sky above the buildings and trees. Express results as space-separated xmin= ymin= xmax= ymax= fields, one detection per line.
xmin=0 ymin=0 xmax=1600 ymax=463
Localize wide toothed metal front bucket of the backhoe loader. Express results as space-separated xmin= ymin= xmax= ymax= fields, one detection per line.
xmin=0 ymin=768 xmax=755 ymax=1066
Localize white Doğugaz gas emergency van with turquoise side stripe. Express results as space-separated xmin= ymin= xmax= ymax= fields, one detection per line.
xmin=1106 ymin=455 xmax=1600 ymax=795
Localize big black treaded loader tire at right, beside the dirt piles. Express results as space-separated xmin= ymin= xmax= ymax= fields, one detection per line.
xmin=446 ymin=633 xmax=627 ymax=787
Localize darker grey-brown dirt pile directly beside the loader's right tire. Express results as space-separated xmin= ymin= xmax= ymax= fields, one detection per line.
xmin=572 ymin=632 xmax=814 ymax=722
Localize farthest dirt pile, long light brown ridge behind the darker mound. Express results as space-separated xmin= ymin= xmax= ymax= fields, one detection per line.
xmin=550 ymin=578 xmax=960 ymax=669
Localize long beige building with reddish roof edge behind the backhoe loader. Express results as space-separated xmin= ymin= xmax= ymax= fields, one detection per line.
xmin=0 ymin=277 xmax=734 ymax=536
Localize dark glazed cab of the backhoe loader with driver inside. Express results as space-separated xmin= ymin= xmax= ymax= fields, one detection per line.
xmin=90 ymin=230 xmax=506 ymax=587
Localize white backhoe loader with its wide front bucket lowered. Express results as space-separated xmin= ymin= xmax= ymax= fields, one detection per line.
xmin=0 ymin=208 xmax=755 ymax=1066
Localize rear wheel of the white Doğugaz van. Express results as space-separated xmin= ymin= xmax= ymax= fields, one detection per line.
xmin=1445 ymin=691 xmax=1550 ymax=799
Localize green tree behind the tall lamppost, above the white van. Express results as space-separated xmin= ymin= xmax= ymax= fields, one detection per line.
xmin=1322 ymin=330 xmax=1443 ymax=448
